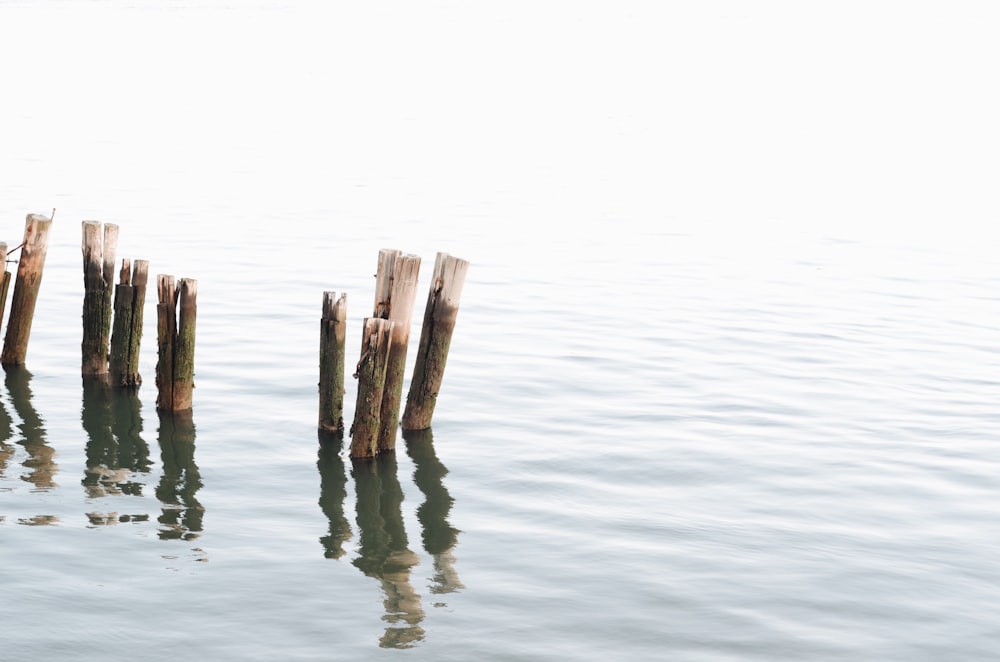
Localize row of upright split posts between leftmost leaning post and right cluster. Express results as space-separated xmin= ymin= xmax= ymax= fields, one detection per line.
xmin=81 ymin=221 xmax=198 ymax=411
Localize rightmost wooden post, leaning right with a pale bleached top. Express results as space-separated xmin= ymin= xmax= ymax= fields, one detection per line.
xmin=402 ymin=253 xmax=469 ymax=430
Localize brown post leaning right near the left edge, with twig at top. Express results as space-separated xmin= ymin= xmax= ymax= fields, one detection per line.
xmin=0 ymin=214 xmax=52 ymax=366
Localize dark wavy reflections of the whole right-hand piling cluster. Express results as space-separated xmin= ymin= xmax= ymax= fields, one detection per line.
xmin=317 ymin=430 xmax=463 ymax=648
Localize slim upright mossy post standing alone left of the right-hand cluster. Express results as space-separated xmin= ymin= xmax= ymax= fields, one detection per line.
xmin=319 ymin=292 xmax=347 ymax=433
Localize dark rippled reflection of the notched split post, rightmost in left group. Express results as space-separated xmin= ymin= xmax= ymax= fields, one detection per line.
xmin=156 ymin=410 xmax=205 ymax=540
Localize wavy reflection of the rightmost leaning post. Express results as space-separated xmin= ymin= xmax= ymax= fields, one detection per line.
xmin=403 ymin=429 xmax=465 ymax=594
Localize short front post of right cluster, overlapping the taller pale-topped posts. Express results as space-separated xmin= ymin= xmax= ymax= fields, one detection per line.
xmin=351 ymin=317 xmax=393 ymax=458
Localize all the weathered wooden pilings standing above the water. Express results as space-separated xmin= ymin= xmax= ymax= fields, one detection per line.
xmin=0 ymin=210 xmax=469 ymax=446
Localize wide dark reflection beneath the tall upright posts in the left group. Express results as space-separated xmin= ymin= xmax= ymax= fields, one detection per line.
xmin=81 ymin=378 xmax=151 ymax=526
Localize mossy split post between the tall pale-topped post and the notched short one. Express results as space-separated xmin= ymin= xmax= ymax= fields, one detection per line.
xmin=109 ymin=258 xmax=149 ymax=386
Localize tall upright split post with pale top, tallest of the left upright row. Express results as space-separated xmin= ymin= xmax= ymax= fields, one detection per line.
xmin=80 ymin=221 xmax=118 ymax=377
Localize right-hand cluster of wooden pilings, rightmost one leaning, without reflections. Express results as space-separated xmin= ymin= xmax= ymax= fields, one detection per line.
xmin=319 ymin=249 xmax=469 ymax=458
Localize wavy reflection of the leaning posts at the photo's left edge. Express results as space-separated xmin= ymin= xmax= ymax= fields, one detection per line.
xmin=0 ymin=366 xmax=59 ymax=526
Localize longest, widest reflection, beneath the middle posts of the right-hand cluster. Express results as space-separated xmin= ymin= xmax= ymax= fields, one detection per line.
xmin=351 ymin=453 xmax=424 ymax=648
